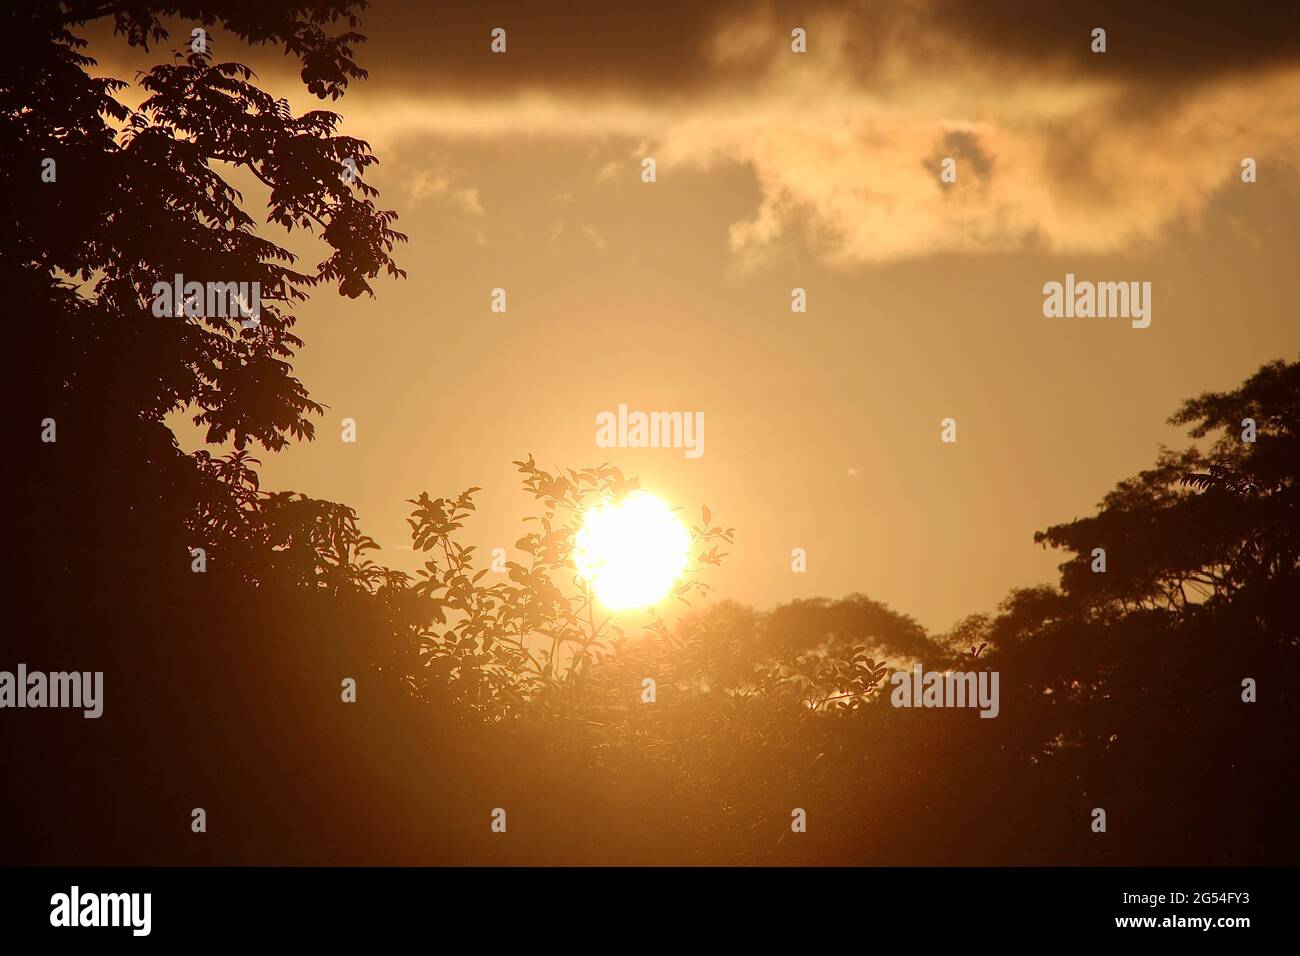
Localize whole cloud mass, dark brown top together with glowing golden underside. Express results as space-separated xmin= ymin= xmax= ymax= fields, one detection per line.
xmin=78 ymin=0 xmax=1300 ymax=265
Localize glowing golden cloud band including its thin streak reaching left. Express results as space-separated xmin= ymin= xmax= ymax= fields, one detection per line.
xmin=343 ymin=51 xmax=1300 ymax=265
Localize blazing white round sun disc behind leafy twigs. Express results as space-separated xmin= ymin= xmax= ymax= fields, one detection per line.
xmin=573 ymin=492 xmax=690 ymax=611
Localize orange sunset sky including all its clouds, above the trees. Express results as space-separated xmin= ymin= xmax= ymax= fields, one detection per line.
xmin=87 ymin=0 xmax=1300 ymax=630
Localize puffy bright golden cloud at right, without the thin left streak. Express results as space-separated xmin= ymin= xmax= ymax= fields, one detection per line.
xmin=702 ymin=70 xmax=1300 ymax=264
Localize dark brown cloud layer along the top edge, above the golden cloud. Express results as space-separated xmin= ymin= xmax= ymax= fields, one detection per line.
xmin=79 ymin=0 xmax=1300 ymax=98
